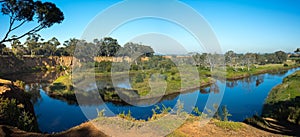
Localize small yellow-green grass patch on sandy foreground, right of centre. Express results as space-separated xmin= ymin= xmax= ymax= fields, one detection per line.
xmin=214 ymin=121 xmax=244 ymax=131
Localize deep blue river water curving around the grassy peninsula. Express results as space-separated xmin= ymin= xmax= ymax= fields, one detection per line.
xmin=6 ymin=68 xmax=300 ymax=133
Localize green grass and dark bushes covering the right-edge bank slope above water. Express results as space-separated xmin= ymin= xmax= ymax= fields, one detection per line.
xmin=262 ymin=71 xmax=300 ymax=125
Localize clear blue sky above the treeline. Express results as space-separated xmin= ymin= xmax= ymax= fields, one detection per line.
xmin=0 ymin=0 xmax=300 ymax=53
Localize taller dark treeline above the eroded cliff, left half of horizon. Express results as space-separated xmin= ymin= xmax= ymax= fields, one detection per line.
xmin=0 ymin=35 xmax=154 ymax=57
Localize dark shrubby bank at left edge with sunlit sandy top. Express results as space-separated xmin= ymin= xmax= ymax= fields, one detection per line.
xmin=0 ymin=79 xmax=39 ymax=132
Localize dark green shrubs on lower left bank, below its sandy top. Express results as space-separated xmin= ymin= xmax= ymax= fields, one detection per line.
xmin=0 ymin=98 xmax=37 ymax=131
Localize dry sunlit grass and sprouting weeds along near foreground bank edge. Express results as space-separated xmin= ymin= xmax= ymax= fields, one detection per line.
xmin=93 ymin=101 xmax=245 ymax=136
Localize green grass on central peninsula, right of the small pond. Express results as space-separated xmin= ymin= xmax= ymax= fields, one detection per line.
xmin=131 ymin=68 xmax=212 ymax=96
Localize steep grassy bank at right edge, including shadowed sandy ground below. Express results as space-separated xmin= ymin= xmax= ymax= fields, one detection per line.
xmin=245 ymin=71 xmax=300 ymax=136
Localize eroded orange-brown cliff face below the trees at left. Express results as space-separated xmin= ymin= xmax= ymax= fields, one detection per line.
xmin=0 ymin=56 xmax=73 ymax=75
